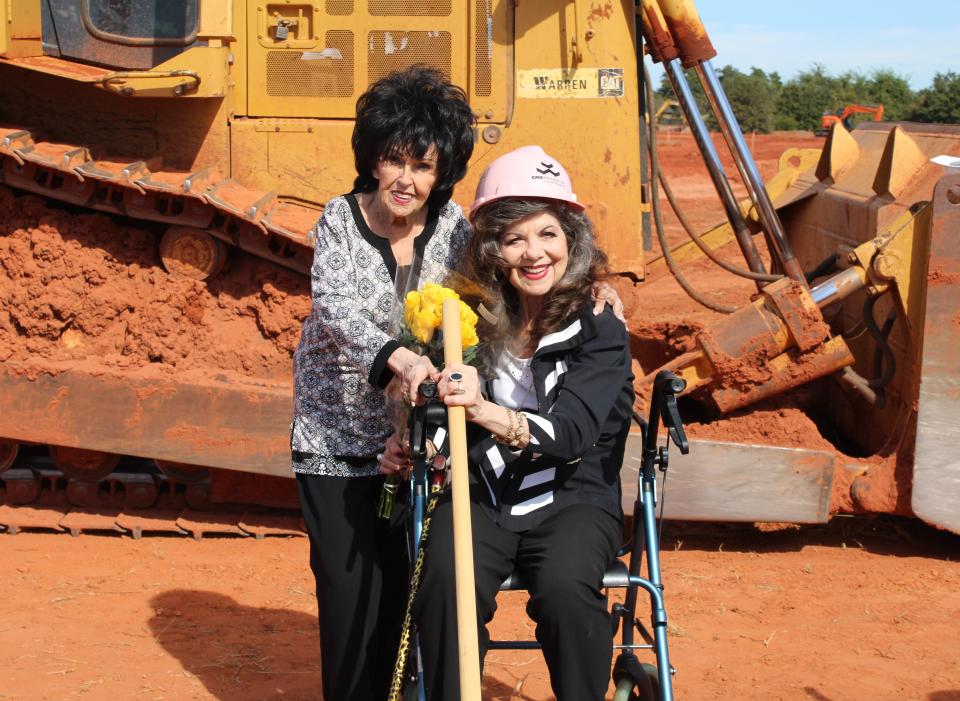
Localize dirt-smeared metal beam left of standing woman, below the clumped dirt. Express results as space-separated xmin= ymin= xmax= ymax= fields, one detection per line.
xmin=0 ymin=362 xmax=292 ymax=477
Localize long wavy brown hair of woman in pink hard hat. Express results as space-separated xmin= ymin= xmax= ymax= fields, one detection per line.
xmin=466 ymin=198 xmax=607 ymax=348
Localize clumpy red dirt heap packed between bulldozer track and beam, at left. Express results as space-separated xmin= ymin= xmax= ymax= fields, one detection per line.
xmin=0 ymin=189 xmax=310 ymax=379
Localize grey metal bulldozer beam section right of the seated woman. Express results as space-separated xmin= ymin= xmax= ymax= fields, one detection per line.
xmin=620 ymin=433 xmax=836 ymax=523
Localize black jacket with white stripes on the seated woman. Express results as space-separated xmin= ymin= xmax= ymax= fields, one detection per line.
xmin=468 ymin=305 xmax=633 ymax=531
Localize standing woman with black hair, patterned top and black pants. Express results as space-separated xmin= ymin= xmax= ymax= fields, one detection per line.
xmin=291 ymin=66 xmax=474 ymax=701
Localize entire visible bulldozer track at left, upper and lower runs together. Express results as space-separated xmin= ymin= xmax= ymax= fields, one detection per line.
xmin=0 ymin=125 xmax=320 ymax=539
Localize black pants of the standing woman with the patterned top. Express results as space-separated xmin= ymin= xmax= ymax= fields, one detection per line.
xmin=297 ymin=474 xmax=409 ymax=701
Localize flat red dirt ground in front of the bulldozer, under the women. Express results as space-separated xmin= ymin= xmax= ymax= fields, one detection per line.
xmin=0 ymin=518 xmax=960 ymax=701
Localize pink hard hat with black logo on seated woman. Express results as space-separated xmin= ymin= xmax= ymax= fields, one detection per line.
xmin=470 ymin=146 xmax=583 ymax=219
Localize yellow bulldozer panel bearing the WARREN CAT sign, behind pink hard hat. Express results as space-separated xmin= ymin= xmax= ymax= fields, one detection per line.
xmin=502 ymin=0 xmax=643 ymax=274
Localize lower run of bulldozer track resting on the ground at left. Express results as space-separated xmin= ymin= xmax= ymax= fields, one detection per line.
xmin=0 ymin=451 xmax=304 ymax=540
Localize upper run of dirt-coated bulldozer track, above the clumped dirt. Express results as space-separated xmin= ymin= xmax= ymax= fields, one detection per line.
xmin=0 ymin=126 xmax=320 ymax=274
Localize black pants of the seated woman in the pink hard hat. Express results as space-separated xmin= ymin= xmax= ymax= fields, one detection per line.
xmin=414 ymin=498 xmax=620 ymax=701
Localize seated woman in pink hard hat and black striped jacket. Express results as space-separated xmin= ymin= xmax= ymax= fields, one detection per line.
xmin=414 ymin=146 xmax=633 ymax=701
